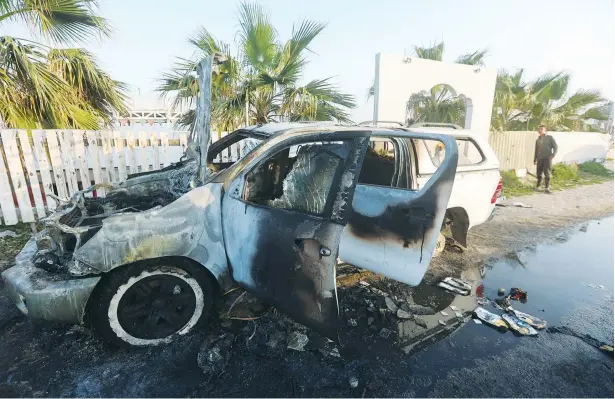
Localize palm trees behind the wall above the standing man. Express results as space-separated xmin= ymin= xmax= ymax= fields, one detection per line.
xmin=491 ymin=69 xmax=608 ymax=131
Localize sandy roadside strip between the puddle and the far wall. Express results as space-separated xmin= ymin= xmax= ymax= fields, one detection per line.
xmin=429 ymin=178 xmax=614 ymax=282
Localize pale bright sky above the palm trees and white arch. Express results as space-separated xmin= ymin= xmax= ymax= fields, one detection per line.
xmin=0 ymin=0 xmax=615 ymax=121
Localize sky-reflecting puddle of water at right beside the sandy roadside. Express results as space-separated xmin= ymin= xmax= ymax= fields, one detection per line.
xmin=483 ymin=217 xmax=613 ymax=325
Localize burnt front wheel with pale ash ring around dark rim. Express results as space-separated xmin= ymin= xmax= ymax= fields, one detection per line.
xmin=90 ymin=265 xmax=213 ymax=346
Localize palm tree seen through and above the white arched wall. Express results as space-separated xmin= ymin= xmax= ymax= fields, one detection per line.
xmin=368 ymin=42 xmax=488 ymax=125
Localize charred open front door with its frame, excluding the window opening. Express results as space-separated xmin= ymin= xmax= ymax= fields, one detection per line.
xmin=222 ymin=132 xmax=369 ymax=337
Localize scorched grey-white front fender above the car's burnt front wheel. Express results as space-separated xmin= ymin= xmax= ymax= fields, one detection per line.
xmin=74 ymin=183 xmax=228 ymax=290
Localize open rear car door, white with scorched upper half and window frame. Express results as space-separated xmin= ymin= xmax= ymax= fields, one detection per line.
xmin=339 ymin=132 xmax=457 ymax=285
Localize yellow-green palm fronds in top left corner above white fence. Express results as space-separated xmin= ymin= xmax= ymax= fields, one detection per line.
xmin=0 ymin=0 xmax=125 ymax=129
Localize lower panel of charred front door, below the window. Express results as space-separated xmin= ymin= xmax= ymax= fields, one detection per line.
xmin=223 ymin=199 xmax=343 ymax=338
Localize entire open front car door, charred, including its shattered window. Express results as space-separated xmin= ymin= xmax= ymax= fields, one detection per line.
xmin=222 ymin=132 xmax=369 ymax=336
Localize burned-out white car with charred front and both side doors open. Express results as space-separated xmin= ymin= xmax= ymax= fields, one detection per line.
xmin=2 ymin=57 xmax=457 ymax=345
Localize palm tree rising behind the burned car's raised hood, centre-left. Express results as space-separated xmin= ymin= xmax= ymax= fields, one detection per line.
xmin=158 ymin=3 xmax=355 ymax=131
